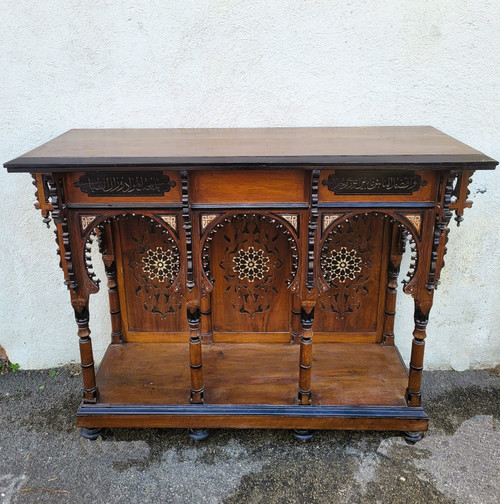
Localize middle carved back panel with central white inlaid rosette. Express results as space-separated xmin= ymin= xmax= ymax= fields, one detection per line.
xmin=209 ymin=215 xmax=292 ymax=333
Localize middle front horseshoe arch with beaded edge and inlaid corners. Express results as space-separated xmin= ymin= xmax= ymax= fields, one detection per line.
xmin=195 ymin=211 xmax=300 ymax=294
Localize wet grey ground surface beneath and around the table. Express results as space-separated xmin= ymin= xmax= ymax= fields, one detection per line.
xmin=0 ymin=369 xmax=500 ymax=504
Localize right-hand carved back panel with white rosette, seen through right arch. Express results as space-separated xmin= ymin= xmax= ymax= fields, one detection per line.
xmin=314 ymin=214 xmax=390 ymax=333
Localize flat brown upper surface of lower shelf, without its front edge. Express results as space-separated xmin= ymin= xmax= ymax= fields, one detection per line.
xmin=97 ymin=343 xmax=408 ymax=406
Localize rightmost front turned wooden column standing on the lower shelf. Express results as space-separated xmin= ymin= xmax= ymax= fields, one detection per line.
xmin=406 ymin=303 xmax=429 ymax=406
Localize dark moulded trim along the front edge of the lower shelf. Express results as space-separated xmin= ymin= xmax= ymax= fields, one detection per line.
xmin=78 ymin=403 xmax=428 ymax=420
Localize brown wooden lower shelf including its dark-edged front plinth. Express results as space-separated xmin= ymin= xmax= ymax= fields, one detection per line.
xmin=78 ymin=343 xmax=427 ymax=431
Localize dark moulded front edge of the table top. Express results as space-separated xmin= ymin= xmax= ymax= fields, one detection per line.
xmin=4 ymin=154 xmax=498 ymax=173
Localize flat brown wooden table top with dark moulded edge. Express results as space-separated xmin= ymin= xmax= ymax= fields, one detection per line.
xmin=4 ymin=126 xmax=497 ymax=172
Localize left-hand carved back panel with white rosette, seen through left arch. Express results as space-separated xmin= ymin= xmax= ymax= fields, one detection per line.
xmin=113 ymin=217 xmax=187 ymax=332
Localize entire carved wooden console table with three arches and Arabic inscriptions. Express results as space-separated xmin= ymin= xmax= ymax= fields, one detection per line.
xmin=5 ymin=127 xmax=497 ymax=442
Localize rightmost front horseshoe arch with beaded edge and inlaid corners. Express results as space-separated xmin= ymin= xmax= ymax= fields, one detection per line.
xmin=315 ymin=209 xmax=434 ymax=297
